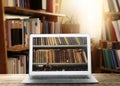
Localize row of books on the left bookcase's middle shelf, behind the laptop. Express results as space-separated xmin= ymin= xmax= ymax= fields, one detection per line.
xmin=5 ymin=18 xmax=60 ymax=48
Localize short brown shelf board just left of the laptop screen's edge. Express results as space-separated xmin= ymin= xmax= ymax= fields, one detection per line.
xmin=7 ymin=45 xmax=29 ymax=52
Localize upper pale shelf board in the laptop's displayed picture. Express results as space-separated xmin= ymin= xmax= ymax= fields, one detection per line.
xmin=33 ymin=45 xmax=87 ymax=49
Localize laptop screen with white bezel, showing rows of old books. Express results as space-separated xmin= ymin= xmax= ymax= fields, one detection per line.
xmin=30 ymin=34 xmax=91 ymax=74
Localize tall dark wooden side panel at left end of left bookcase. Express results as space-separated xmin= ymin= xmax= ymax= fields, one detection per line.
xmin=0 ymin=0 xmax=7 ymax=74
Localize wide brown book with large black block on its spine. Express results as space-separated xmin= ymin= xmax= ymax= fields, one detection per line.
xmin=8 ymin=19 xmax=23 ymax=47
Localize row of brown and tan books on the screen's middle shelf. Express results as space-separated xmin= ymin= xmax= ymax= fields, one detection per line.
xmin=33 ymin=49 xmax=88 ymax=64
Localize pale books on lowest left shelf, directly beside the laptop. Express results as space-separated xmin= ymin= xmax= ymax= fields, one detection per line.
xmin=8 ymin=55 xmax=27 ymax=74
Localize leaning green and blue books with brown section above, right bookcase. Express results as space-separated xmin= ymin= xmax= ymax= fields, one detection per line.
xmin=101 ymin=41 xmax=120 ymax=69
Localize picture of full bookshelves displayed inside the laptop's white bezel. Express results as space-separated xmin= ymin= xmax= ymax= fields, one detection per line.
xmin=31 ymin=37 xmax=88 ymax=71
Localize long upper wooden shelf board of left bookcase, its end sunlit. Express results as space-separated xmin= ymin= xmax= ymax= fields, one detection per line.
xmin=5 ymin=7 xmax=65 ymax=21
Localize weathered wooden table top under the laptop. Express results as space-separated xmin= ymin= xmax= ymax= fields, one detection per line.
xmin=0 ymin=74 xmax=120 ymax=86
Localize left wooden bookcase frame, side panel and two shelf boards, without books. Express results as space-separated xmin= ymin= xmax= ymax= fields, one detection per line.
xmin=0 ymin=0 xmax=65 ymax=74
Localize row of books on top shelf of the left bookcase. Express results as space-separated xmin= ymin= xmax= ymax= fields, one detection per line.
xmin=3 ymin=0 xmax=62 ymax=13
